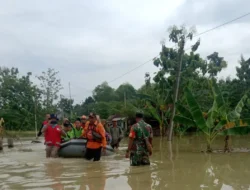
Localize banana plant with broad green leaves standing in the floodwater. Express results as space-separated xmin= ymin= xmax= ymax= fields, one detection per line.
xmin=175 ymin=80 xmax=250 ymax=152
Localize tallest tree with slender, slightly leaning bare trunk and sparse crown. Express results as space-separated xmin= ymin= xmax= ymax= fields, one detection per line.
xmin=154 ymin=26 xmax=200 ymax=141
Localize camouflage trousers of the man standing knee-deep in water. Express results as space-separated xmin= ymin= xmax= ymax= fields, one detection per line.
xmin=130 ymin=151 xmax=150 ymax=166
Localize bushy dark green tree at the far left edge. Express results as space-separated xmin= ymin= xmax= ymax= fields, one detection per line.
xmin=0 ymin=68 xmax=40 ymax=130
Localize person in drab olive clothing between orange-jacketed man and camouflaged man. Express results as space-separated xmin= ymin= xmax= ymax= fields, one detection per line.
xmin=110 ymin=121 xmax=123 ymax=150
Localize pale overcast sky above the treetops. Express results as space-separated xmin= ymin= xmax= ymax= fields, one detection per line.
xmin=0 ymin=0 xmax=250 ymax=102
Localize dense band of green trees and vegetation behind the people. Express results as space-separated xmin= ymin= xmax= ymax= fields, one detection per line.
xmin=0 ymin=26 xmax=250 ymax=138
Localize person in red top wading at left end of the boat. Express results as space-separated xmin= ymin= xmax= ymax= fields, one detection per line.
xmin=42 ymin=114 xmax=65 ymax=158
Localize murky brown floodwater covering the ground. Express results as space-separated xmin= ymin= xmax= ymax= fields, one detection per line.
xmin=0 ymin=136 xmax=250 ymax=190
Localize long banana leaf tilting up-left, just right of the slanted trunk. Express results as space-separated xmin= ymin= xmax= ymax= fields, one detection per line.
xmin=185 ymin=88 xmax=208 ymax=133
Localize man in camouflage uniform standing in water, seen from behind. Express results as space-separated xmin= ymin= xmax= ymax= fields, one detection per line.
xmin=126 ymin=113 xmax=153 ymax=166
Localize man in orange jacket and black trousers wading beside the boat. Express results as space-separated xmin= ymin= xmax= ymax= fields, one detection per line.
xmin=82 ymin=113 xmax=107 ymax=161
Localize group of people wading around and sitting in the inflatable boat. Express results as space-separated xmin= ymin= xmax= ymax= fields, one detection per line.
xmin=38 ymin=113 xmax=153 ymax=166
